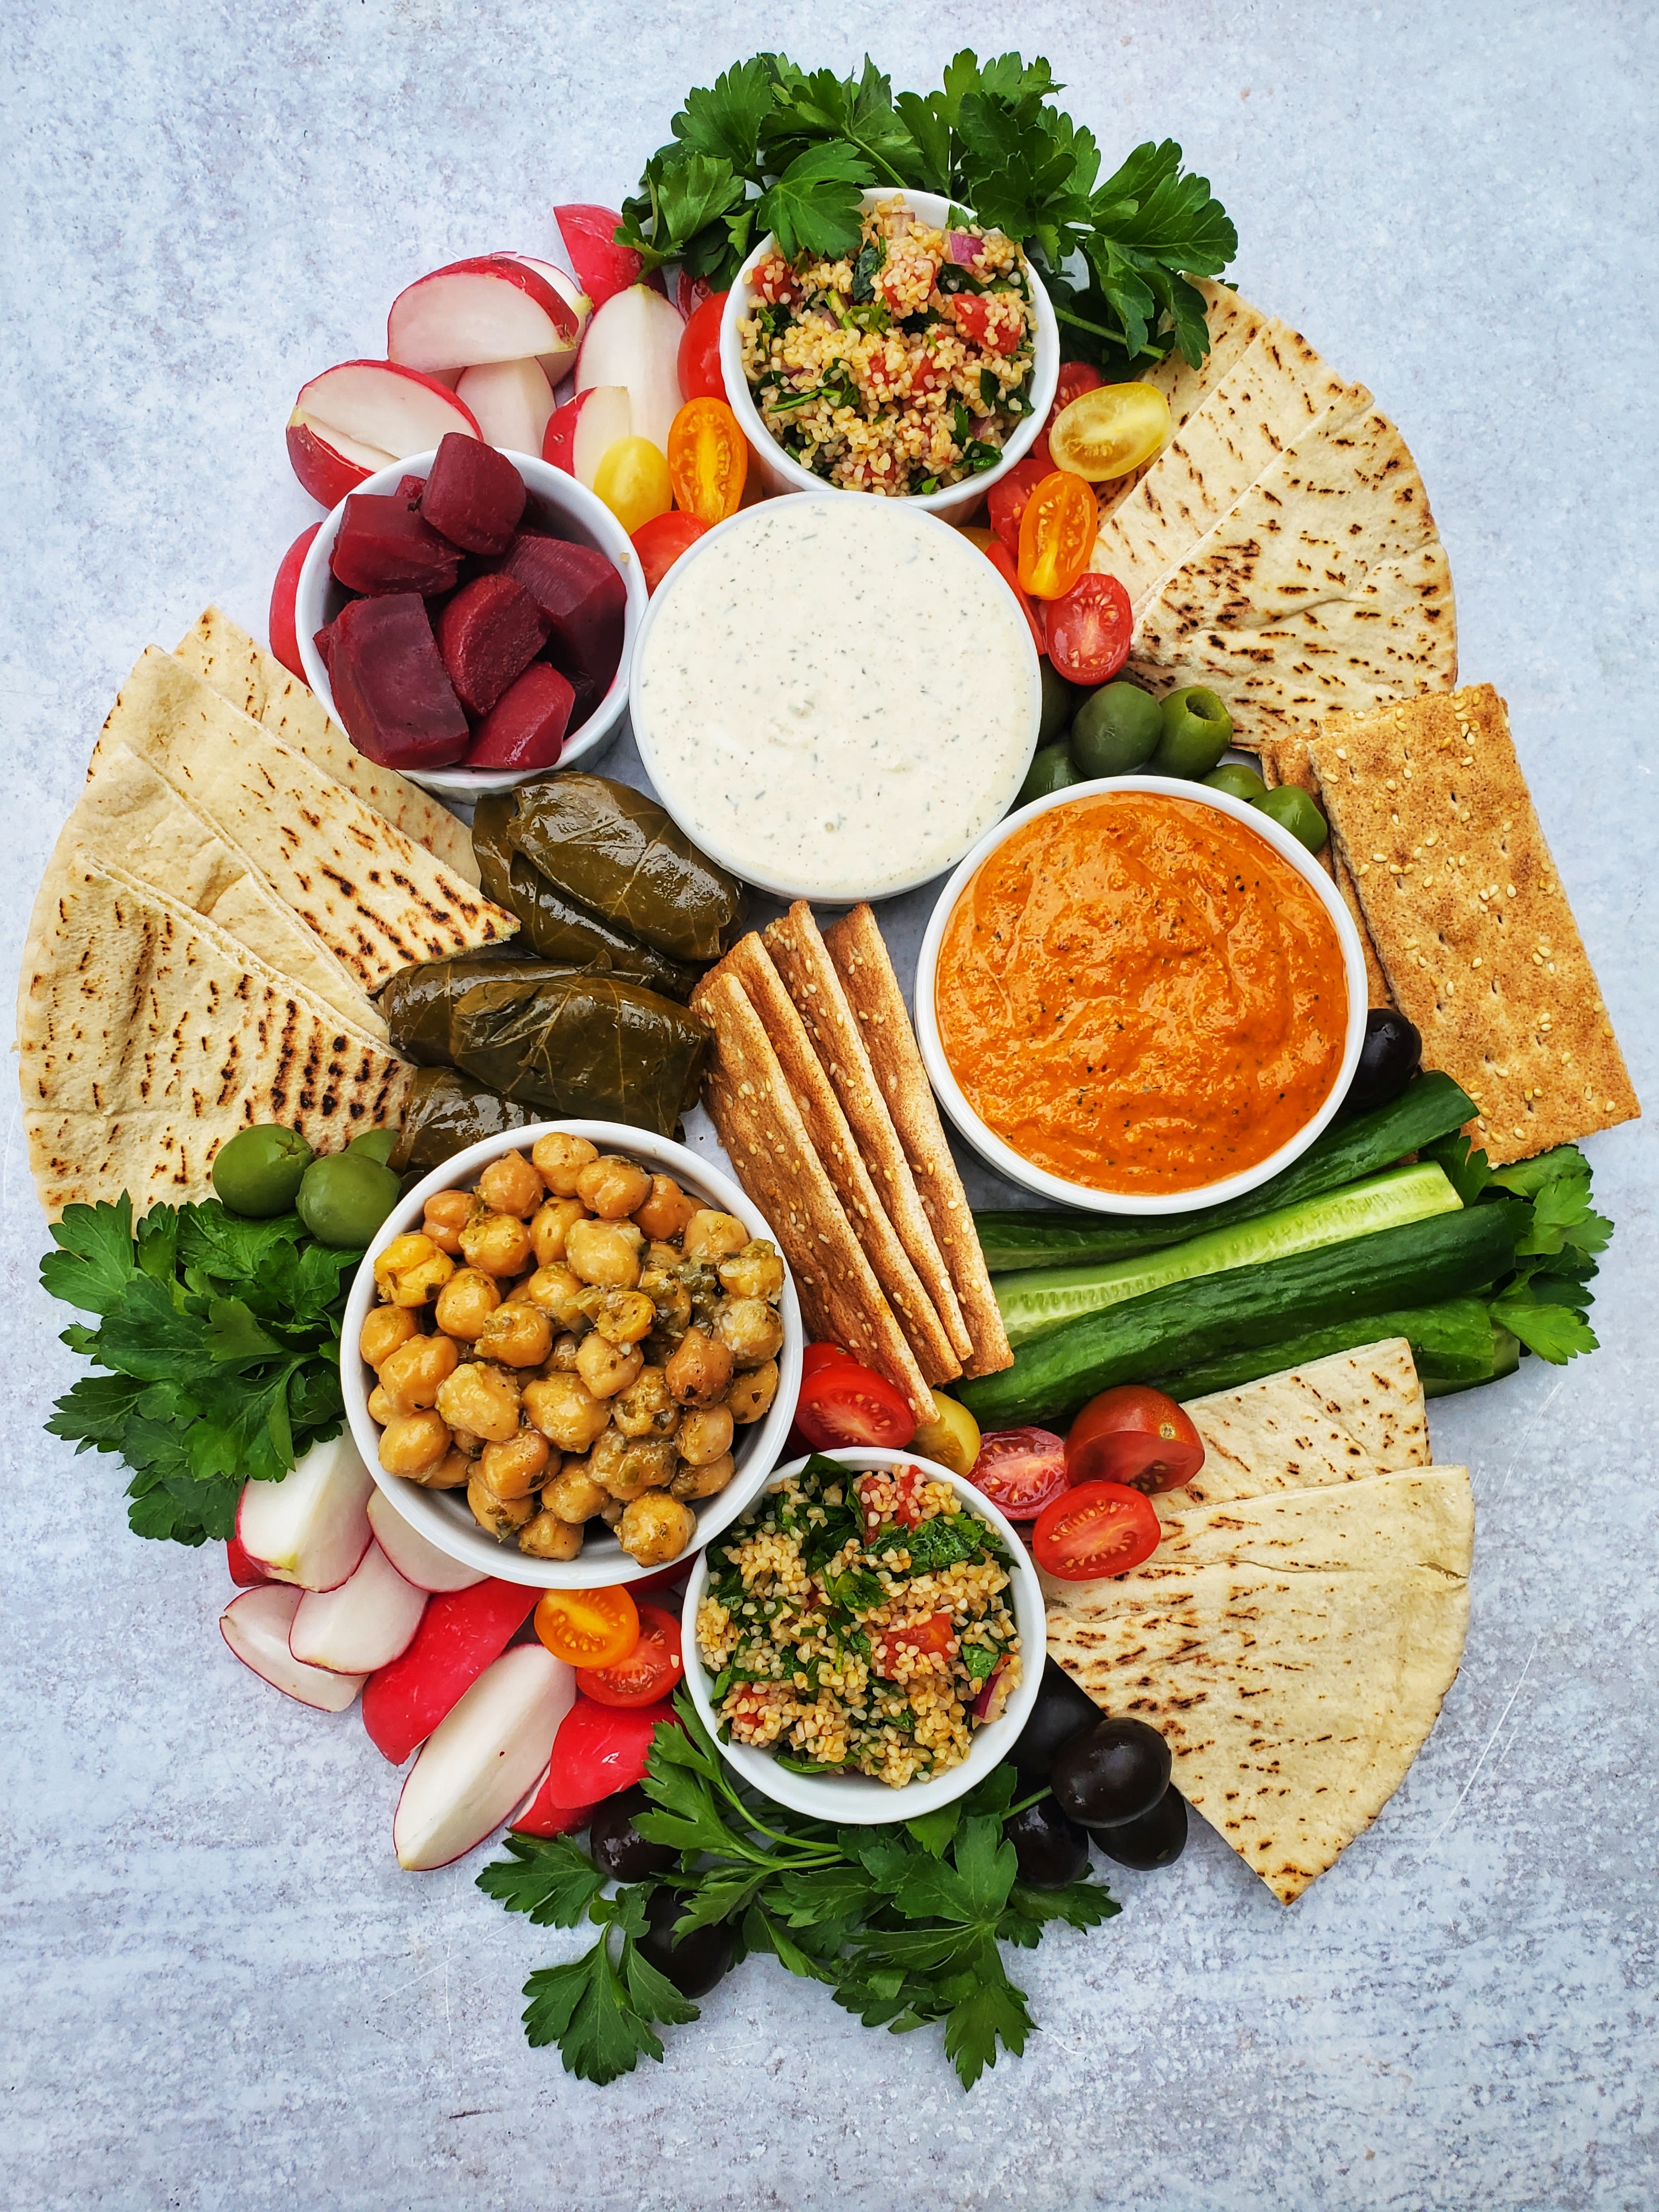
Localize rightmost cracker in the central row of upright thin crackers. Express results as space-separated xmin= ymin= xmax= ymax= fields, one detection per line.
xmin=823 ymin=905 xmax=1013 ymax=1376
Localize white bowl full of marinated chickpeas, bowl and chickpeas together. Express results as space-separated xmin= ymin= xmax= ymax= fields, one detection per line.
xmin=341 ymin=1121 xmax=803 ymax=1590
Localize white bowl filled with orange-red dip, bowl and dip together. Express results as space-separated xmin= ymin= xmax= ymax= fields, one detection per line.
xmin=916 ymin=776 xmax=1367 ymax=1215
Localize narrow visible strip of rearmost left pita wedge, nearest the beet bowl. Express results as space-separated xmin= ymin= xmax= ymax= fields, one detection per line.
xmin=172 ymin=606 xmax=478 ymax=885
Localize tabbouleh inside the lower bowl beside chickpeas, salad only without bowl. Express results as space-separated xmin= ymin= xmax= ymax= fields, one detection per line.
xmin=697 ymin=1455 xmax=1020 ymax=1790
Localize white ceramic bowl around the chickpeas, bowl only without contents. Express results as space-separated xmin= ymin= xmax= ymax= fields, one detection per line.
xmin=341 ymin=1121 xmax=803 ymax=1590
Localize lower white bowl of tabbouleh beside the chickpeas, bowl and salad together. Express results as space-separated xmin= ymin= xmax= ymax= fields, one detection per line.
xmin=684 ymin=1447 xmax=1046 ymax=1827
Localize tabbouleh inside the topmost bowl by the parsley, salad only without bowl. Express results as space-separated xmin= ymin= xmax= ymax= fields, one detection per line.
xmin=739 ymin=199 xmax=1035 ymax=495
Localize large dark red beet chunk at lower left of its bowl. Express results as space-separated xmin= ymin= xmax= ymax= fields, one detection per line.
xmin=319 ymin=591 xmax=471 ymax=770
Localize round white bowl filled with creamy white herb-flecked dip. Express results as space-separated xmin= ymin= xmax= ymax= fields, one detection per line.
xmin=633 ymin=493 xmax=1042 ymax=900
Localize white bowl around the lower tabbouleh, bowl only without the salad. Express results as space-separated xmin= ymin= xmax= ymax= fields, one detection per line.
xmin=681 ymin=1447 xmax=1048 ymax=1827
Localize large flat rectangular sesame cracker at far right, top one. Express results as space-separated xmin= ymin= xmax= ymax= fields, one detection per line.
xmin=1312 ymin=684 xmax=1641 ymax=1166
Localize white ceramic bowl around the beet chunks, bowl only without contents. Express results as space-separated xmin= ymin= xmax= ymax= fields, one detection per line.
xmin=294 ymin=454 xmax=646 ymax=801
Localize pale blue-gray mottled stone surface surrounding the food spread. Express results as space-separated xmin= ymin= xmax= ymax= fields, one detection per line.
xmin=0 ymin=0 xmax=1659 ymax=2212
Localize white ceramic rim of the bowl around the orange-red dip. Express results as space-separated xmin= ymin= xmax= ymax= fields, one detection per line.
xmin=916 ymin=776 xmax=1367 ymax=1215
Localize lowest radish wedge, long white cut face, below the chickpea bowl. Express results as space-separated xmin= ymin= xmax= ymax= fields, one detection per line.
xmin=392 ymin=1644 xmax=575 ymax=1874
